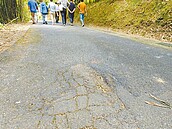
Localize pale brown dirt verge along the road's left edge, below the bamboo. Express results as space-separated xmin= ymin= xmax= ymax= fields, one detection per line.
xmin=0 ymin=24 xmax=30 ymax=53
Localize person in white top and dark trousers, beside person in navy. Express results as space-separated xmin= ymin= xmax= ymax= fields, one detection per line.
xmin=59 ymin=0 xmax=69 ymax=26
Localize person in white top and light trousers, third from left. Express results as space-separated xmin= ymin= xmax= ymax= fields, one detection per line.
xmin=48 ymin=0 xmax=56 ymax=25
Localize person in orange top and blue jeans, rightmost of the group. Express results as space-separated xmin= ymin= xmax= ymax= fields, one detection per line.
xmin=77 ymin=0 xmax=87 ymax=27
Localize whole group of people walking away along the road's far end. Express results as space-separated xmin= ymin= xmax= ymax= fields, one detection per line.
xmin=28 ymin=0 xmax=87 ymax=27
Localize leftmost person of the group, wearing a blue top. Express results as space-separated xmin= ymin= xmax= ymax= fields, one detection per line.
xmin=28 ymin=0 xmax=38 ymax=24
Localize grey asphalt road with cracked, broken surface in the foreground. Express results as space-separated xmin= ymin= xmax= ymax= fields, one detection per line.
xmin=0 ymin=24 xmax=172 ymax=129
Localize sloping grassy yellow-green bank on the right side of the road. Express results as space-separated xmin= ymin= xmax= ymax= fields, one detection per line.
xmin=86 ymin=0 xmax=172 ymax=42
